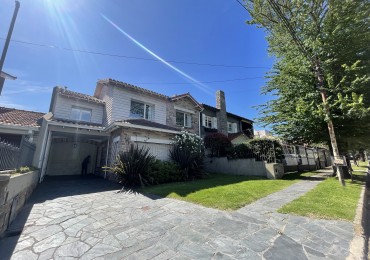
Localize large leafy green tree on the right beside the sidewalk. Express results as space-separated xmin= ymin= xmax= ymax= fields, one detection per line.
xmin=245 ymin=0 xmax=370 ymax=185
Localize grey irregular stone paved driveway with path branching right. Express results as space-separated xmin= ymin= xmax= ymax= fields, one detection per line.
xmin=0 ymin=178 xmax=354 ymax=260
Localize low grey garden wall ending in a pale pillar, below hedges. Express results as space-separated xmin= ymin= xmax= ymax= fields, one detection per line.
xmin=204 ymin=157 xmax=284 ymax=179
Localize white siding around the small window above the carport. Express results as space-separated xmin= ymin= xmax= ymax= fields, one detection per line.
xmin=52 ymin=94 xmax=104 ymax=124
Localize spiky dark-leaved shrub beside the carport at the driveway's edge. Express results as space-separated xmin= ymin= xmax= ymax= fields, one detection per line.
xmin=108 ymin=145 xmax=155 ymax=186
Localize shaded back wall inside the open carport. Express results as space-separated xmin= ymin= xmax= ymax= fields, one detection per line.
xmin=46 ymin=142 xmax=97 ymax=176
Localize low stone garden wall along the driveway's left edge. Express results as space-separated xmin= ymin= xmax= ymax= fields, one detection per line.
xmin=0 ymin=171 xmax=39 ymax=237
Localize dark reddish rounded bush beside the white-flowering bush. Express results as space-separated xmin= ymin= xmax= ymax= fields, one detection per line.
xmin=204 ymin=133 xmax=232 ymax=157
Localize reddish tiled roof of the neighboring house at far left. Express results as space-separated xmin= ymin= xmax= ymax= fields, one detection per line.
xmin=0 ymin=107 xmax=45 ymax=127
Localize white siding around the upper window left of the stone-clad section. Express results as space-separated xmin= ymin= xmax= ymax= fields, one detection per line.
xmin=108 ymin=87 xmax=166 ymax=124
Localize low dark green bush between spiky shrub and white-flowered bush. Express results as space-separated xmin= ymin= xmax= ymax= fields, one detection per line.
xmin=148 ymin=160 xmax=182 ymax=184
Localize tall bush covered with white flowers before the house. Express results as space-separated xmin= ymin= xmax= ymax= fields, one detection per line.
xmin=170 ymin=131 xmax=204 ymax=180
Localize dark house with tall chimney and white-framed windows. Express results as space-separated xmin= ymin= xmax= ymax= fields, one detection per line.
xmin=200 ymin=90 xmax=253 ymax=144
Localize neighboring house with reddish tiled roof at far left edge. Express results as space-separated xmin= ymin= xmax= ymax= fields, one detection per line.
xmin=0 ymin=107 xmax=45 ymax=147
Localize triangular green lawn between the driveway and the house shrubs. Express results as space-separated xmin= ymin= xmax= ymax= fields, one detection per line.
xmin=138 ymin=174 xmax=296 ymax=210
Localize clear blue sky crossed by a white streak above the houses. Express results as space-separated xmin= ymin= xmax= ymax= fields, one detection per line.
xmin=0 ymin=0 xmax=273 ymax=128
